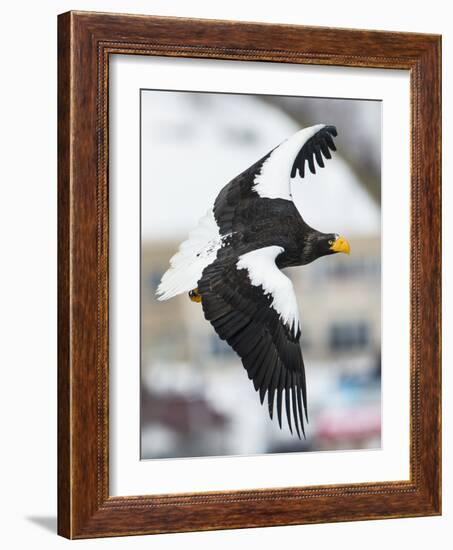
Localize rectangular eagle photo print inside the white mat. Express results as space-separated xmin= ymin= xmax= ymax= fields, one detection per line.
xmin=140 ymin=89 xmax=381 ymax=459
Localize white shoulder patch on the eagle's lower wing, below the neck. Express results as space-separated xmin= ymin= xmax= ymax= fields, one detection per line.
xmin=236 ymin=246 xmax=299 ymax=335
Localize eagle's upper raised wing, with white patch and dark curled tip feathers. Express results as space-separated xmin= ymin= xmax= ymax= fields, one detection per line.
xmin=214 ymin=124 xmax=337 ymax=239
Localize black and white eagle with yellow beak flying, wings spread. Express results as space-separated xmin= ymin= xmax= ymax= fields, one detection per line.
xmin=156 ymin=124 xmax=350 ymax=439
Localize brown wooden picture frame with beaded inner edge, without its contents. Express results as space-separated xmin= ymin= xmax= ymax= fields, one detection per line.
xmin=58 ymin=12 xmax=441 ymax=538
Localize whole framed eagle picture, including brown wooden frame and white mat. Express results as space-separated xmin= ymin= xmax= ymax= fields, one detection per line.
xmin=58 ymin=12 xmax=441 ymax=538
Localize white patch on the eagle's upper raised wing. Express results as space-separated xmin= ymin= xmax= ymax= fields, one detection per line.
xmin=253 ymin=124 xmax=325 ymax=200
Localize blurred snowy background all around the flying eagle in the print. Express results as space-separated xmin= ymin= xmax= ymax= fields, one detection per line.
xmin=141 ymin=90 xmax=381 ymax=459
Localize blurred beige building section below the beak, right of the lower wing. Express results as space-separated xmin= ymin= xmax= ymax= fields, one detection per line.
xmin=287 ymin=235 xmax=381 ymax=361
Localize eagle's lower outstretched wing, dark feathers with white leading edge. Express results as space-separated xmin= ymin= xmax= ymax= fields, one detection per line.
xmin=198 ymin=246 xmax=307 ymax=438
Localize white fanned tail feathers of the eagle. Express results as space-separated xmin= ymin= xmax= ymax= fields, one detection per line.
xmin=156 ymin=210 xmax=226 ymax=300
